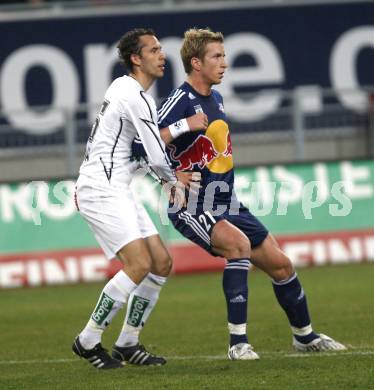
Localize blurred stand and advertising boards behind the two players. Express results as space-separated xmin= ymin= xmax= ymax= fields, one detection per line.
xmin=0 ymin=0 xmax=374 ymax=288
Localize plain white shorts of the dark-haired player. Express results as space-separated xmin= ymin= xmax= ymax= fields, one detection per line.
xmin=77 ymin=176 xmax=158 ymax=259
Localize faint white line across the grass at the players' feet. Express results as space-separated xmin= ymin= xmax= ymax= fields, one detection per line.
xmin=0 ymin=347 xmax=374 ymax=366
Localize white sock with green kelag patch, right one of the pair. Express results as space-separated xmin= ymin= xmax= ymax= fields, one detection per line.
xmin=116 ymin=273 xmax=167 ymax=347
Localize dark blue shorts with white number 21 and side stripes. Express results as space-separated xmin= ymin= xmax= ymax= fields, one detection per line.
xmin=169 ymin=203 xmax=269 ymax=256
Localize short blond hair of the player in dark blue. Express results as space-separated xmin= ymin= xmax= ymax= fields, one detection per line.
xmin=180 ymin=28 xmax=223 ymax=74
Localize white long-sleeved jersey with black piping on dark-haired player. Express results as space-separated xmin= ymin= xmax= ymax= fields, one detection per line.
xmin=79 ymin=76 xmax=177 ymax=185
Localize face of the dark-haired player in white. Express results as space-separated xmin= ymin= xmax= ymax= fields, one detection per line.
xmin=139 ymin=35 xmax=166 ymax=78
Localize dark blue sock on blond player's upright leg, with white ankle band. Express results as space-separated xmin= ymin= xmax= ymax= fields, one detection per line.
xmin=222 ymin=259 xmax=249 ymax=346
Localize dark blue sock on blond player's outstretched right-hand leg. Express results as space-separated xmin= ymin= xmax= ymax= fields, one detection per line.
xmin=273 ymin=273 xmax=318 ymax=343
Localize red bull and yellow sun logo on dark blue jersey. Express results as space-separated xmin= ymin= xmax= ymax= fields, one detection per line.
xmin=169 ymin=119 xmax=234 ymax=173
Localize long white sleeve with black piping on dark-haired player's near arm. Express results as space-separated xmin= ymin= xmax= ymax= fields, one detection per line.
xmin=125 ymin=97 xmax=177 ymax=183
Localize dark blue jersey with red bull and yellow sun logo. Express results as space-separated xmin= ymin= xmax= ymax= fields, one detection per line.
xmin=158 ymin=82 xmax=234 ymax=204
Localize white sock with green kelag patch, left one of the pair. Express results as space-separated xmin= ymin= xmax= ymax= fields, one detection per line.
xmin=79 ymin=271 xmax=137 ymax=349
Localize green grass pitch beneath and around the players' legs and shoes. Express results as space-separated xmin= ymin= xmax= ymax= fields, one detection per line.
xmin=0 ymin=264 xmax=374 ymax=390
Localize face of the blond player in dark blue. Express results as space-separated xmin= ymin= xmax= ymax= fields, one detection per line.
xmin=201 ymin=42 xmax=227 ymax=85
